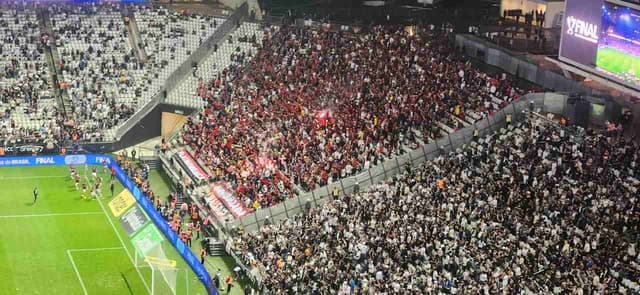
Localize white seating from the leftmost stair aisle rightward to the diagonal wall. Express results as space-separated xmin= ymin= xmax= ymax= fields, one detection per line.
xmin=38 ymin=3 xmax=229 ymax=141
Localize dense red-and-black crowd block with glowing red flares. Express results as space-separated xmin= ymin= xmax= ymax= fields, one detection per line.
xmin=182 ymin=26 xmax=523 ymax=212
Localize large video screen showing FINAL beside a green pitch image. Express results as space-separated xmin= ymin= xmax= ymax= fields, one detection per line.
xmin=560 ymin=0 xmax=640 ymax=90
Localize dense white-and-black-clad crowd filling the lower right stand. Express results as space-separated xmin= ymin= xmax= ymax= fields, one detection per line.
xmin=235 ymin=122 xmax=640 ymax=294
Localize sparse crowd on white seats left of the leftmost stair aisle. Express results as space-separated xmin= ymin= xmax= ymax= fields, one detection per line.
xmin=0 ymin=4 xmax=76 ymax=146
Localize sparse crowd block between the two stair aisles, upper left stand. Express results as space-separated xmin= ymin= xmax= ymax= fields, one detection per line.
xmin=47 ymin=3 xmax=140 ymax=141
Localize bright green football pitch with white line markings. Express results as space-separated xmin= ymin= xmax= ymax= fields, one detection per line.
xmin=0 ymin=166 xmax=206 ymax=295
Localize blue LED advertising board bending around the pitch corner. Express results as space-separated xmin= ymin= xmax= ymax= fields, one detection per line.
xmin=0 ymin=154 xmax=219 ymax=295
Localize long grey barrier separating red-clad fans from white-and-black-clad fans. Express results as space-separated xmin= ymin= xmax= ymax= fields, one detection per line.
xmin=225 ymin=93 xmax=567 ymax=232
